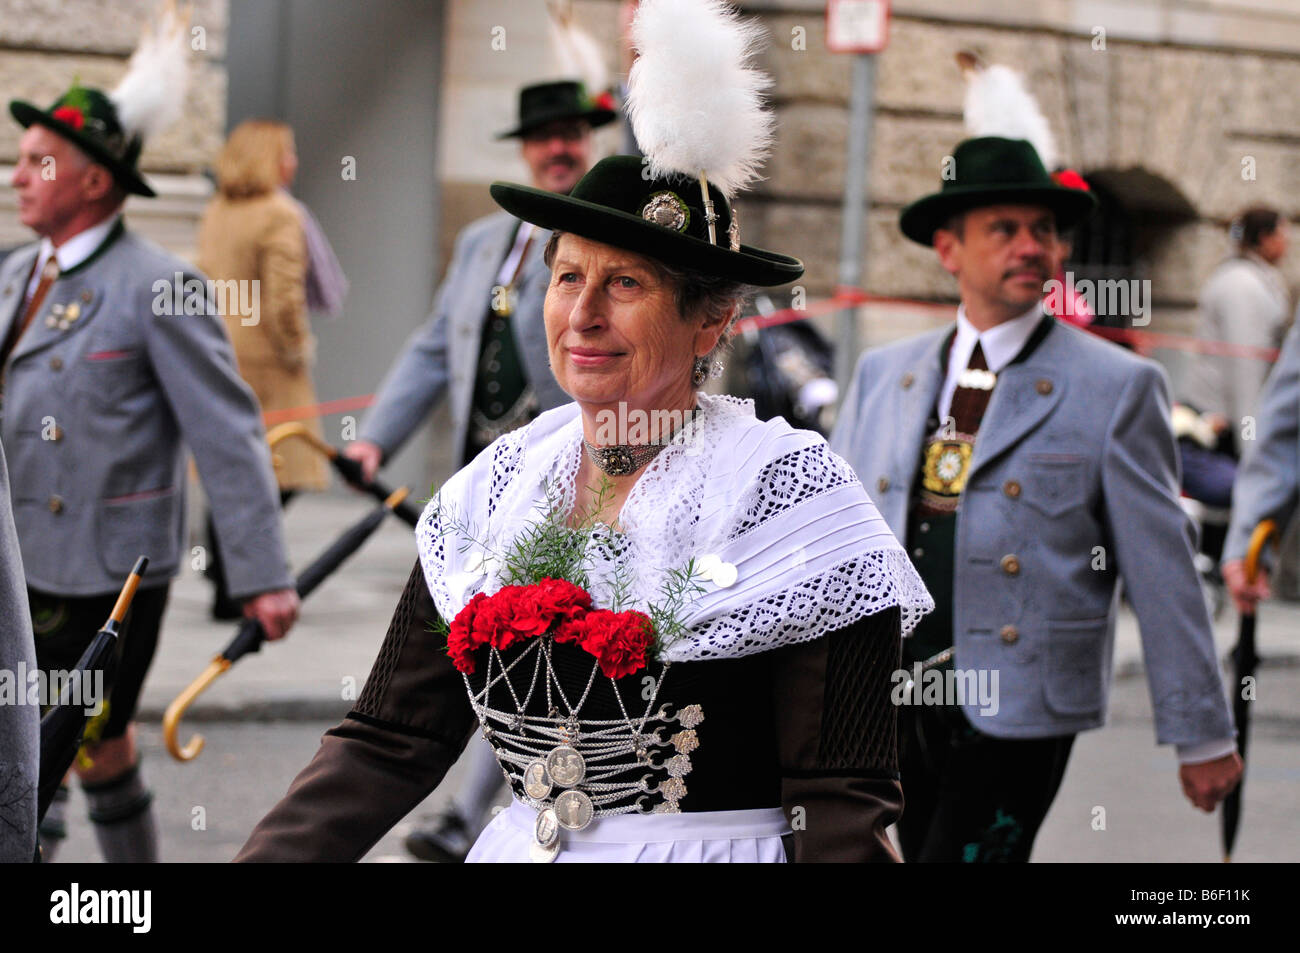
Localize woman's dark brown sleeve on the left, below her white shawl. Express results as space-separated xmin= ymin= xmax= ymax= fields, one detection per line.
xmin=235 ymin=562 xmax=477 ymax=862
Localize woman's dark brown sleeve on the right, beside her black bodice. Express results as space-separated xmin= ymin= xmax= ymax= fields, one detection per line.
xmin=772 ymin=608 xmax=902 ymax=863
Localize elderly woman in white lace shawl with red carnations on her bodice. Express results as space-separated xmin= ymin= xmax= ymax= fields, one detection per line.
xmin=238 ymin=0 xmax=932 ymax=862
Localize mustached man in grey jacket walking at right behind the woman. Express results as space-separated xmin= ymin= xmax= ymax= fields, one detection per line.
xmin=831 ymin=137 xmax=1242 ymax=862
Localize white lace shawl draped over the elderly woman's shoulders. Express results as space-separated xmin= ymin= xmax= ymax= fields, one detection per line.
xmin=417 ymin=394 xmax=933 ymax=662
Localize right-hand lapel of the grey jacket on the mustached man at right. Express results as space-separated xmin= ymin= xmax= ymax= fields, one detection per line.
xmin=970 ymin=328 xmax=1066 ymax=478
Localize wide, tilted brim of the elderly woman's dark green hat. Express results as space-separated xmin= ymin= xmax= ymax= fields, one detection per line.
xmin=490 ymin=182 xmax=803 ymax=287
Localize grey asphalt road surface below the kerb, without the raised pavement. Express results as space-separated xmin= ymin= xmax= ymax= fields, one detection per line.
xmin=50 ymin=667 xmax=1300 ymax=863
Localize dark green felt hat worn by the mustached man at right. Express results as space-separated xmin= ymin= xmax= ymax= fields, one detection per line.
xmin=898 ymin=135 xmax=1097 ymax=246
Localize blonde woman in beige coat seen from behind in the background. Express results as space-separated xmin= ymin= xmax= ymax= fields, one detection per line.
xmin=198 ymin=120 xmax=328 ymax=608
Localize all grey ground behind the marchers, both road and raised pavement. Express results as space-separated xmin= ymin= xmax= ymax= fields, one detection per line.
xmin=45 ymin=498 xmax=1300 ymax=862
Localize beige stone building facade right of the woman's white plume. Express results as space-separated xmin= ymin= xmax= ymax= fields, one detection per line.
xmin=748 ymin=0 xmax=1300 ymax=356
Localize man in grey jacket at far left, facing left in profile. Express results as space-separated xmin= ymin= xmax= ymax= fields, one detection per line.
xmin=0 ymin=86 xmax=298 ymax=861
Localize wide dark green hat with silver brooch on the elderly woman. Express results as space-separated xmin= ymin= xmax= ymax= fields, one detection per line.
xmin=491 ymin=156 xmax=803 ymax=287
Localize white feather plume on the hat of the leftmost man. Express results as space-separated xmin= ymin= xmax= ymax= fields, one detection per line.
xmin=108 ymin=0 xmax=190 ymax=139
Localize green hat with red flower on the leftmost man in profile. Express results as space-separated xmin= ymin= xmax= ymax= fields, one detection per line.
xmin=9 ymin=83 xmax=156 ymax=198
